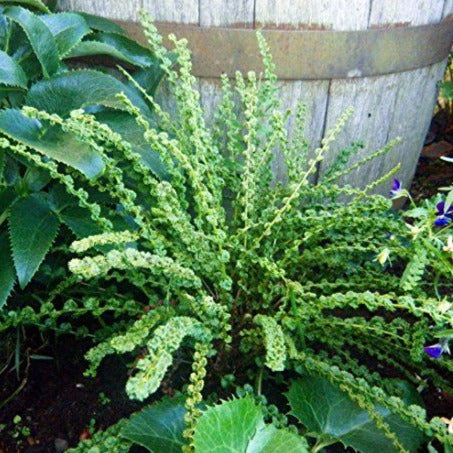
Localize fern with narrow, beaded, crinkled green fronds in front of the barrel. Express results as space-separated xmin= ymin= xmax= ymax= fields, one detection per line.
xmin=0 ymin=12 xmax=453 ymax=452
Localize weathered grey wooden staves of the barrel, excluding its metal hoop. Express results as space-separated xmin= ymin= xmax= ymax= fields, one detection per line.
xmin=61 ymin=0 xmax=453 ymax=194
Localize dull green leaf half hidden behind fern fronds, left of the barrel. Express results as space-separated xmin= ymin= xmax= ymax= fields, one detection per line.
xmin=96 ymin=111 xmax=168 ymax=179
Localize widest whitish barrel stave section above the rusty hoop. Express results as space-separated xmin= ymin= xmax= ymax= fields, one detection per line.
xmin=255 ymin=0 xmax=370 ymax=30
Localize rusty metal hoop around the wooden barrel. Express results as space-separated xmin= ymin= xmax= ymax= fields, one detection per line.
xmin=119 ymin=16 xmax=453 ymax=80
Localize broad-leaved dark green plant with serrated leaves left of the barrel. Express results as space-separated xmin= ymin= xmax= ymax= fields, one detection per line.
xmin=0 ymin=4 xmax=165 ymax=305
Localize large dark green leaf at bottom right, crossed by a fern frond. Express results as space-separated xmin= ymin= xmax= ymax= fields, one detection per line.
xmin=287 ymin=376 xmax=423 ymax=453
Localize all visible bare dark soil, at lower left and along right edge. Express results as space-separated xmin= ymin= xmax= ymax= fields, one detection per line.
xmin=0 ymin=110 xmax=453 ymax=453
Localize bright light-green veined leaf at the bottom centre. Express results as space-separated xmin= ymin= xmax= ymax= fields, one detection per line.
xmin=194 ymin=396 xmax=308 ymax=453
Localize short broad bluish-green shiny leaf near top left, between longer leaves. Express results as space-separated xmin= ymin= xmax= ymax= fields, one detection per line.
xmin=41 ymin=13 xmax=91 ymax=57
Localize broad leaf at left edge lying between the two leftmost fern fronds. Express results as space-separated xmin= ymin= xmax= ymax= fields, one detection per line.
xmin=0 ymin=109 xmax=104 ymax=178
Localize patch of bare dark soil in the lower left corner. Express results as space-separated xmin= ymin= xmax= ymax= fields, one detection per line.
xmin=0 ymin=336 xmax=139 ymax=453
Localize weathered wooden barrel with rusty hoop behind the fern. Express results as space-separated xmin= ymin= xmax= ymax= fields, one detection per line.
xmin=60 ymin=0 xmax=453 ymax=194
